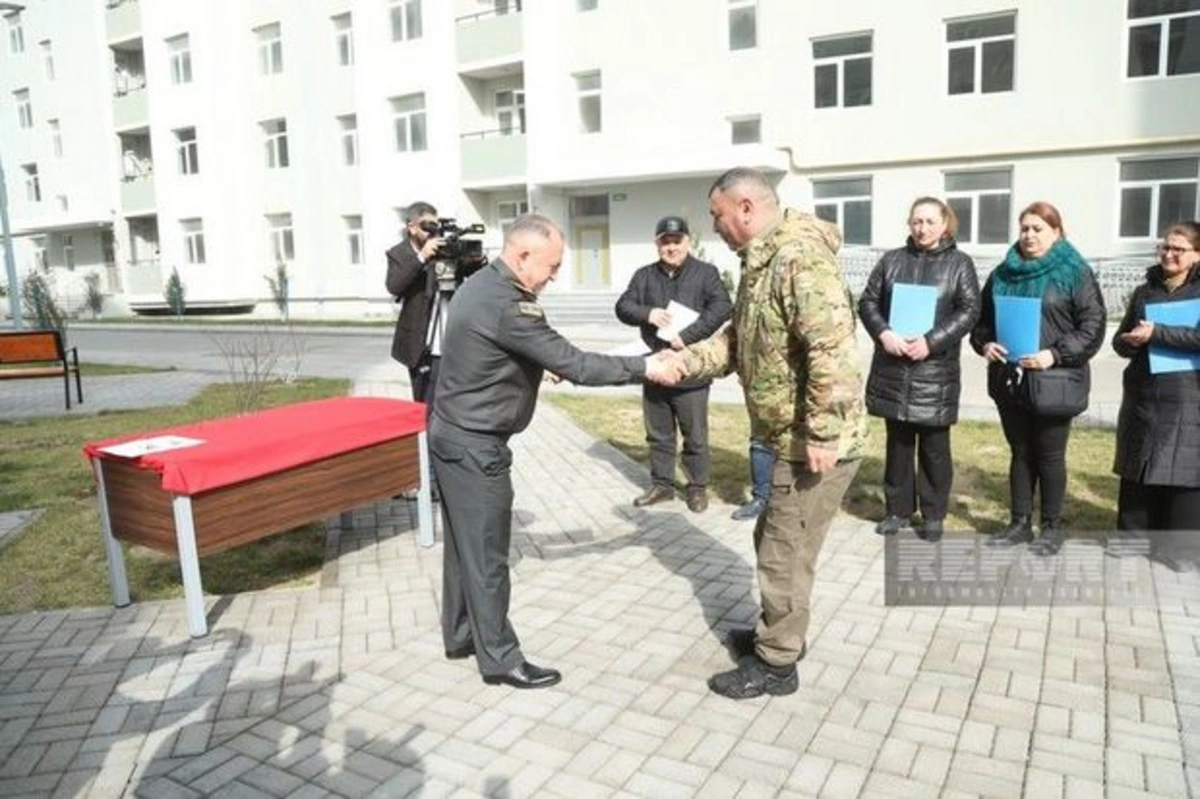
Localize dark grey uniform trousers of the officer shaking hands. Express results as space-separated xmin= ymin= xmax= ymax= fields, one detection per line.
xmin=430 ymin=419 xmax=524 ymax=675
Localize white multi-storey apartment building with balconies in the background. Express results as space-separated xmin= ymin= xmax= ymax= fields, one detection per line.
xmin=0 ymin=0 xmax=1200 ymax=318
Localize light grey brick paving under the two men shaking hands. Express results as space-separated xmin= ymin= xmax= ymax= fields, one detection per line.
xmin=0 ymin=380 xmax=1200 ymax=799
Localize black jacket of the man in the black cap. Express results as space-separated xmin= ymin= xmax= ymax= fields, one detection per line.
xmin=616 ymin=256 xmax=733 ymax=389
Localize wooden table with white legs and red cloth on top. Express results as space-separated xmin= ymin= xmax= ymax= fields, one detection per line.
xmin=84 ymin=397 xmax=433 ymax=637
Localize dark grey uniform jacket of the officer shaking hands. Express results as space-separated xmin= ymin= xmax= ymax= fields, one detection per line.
xmin=433 ymin=258 xmax=646 ymax=437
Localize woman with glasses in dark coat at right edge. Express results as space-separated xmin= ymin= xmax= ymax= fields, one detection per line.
xmin=1112 ymin=222 xmax=1200 ymax=554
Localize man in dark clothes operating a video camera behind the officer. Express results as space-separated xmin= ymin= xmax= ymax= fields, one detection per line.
xmin=388 ymin=203 xmax=445 ymax=405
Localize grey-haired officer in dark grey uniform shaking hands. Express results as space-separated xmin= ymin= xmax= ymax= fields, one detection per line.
xmin=430 ymin=215 xmax=676 ymax=689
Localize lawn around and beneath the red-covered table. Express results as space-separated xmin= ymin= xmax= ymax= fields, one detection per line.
xmin=0 ymin=379 xmax=348 ymax=613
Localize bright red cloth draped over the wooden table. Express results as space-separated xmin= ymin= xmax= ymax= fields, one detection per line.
xmin=83 ymin=397 xmax=425 ymax=495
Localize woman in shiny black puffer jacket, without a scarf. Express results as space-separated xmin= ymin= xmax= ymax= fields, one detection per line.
xmin=858 ymin=197 xmax=979 ymax=541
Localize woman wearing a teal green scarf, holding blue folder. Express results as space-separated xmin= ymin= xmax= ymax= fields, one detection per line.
xmin=971 ymin=202 xmax=1105 ymax=554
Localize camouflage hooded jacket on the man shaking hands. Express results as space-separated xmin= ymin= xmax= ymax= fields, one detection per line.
xmin=684 ymin=209 xmax=866 ymax=461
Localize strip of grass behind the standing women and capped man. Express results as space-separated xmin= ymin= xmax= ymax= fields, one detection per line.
xmin=545 ymin=394 xmax=1118 ymax=533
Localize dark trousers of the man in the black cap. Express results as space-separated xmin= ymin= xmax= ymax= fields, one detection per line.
xmin=642 ymin=383 xmax=712 ymax=487
